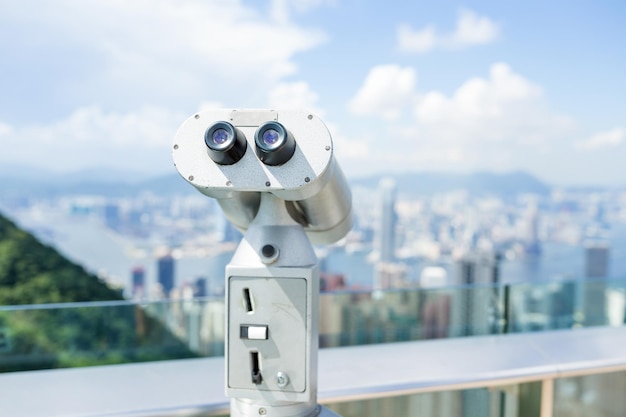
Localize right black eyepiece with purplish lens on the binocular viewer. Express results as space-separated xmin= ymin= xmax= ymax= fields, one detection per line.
xmin=254 ymin=122 xmax=296 ymax=166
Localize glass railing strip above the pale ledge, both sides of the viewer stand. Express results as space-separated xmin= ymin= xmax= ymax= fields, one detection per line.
xmin=0 ymin=279 xmax=626 ymax=371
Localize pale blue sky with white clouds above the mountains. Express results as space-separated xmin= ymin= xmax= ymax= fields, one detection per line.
xmin=0 ymin=0 xmax=626 ymax=185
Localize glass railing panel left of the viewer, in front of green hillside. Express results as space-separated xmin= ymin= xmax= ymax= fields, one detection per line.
xmin=0 ymin=300 xmax=224 ymax=372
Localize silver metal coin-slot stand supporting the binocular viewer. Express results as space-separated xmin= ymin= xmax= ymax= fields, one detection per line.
xmin=226 ymin=193 xmax=338 ymax=417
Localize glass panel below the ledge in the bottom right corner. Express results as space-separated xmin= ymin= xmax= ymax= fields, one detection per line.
xmin=554 ymin=371 xmax=626 ymax=417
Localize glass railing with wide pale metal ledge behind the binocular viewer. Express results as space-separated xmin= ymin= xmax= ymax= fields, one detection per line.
xmin=0 ymin=279 xmax=626 ymax=417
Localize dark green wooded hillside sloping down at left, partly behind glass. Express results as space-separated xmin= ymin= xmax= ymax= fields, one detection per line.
xmin=0 ymin=215 xmax=194 ymax=372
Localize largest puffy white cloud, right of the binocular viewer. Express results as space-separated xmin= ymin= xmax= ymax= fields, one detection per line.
xmin=415 ymin=63 xmax=572 ymax=146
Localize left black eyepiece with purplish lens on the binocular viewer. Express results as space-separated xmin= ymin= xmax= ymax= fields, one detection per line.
xmin=204 ymin=122 xmax=248 ymax=165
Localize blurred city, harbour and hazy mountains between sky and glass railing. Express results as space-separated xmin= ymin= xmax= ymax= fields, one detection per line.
xmin=2 ymin=172 xmax=626 ymax=300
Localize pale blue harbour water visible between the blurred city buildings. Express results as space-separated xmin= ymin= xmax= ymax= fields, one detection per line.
xmin=17 ymin=214 xmax=626 ymax=294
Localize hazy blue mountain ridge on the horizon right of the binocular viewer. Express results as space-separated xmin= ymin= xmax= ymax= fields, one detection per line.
xmin=351 ymin=171 xmax=551 ymax=197
